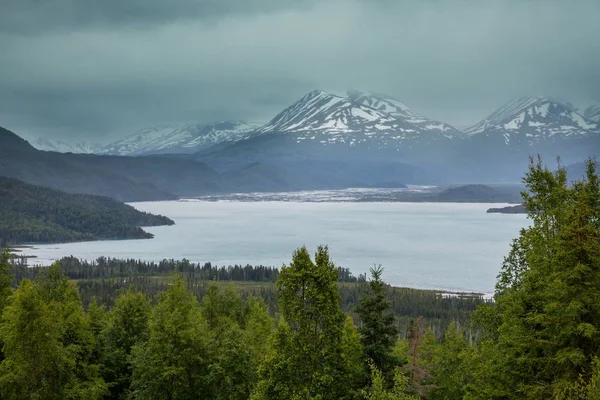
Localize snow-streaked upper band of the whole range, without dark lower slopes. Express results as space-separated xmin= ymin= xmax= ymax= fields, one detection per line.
xmin=33 ymin=90 xmax=600 ymax=168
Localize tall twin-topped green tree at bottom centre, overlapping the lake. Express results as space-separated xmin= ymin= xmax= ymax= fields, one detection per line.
xmin=254 ymin=246 xmax=356 ymax=399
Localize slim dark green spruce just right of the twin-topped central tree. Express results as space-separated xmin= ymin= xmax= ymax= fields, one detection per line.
xmin=356 ymin=266 xmax=399 ymax=383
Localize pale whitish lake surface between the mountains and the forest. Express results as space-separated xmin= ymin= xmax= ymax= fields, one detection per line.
xmin=26 ymin=200 xmax=529 ymax=293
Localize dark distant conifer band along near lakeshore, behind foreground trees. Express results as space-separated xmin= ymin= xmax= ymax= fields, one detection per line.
xmin=13 ymin=257 xmax=485 ymax=338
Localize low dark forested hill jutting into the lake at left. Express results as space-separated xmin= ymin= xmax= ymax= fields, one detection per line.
xmin=0 ymin=177 xmax=174 ymax=244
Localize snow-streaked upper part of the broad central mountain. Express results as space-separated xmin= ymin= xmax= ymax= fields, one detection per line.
xmin=255 ymin=90 xmax=460 ymax=148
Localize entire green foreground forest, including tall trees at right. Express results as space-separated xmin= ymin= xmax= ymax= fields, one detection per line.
xmin=0 ymin=159 xmax=600 ymax=400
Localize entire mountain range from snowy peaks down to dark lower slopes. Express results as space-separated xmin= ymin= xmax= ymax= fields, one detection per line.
xmin=0 ymin=90 xmax=600 ymax=201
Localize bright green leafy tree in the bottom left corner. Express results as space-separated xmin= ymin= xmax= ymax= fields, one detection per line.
xmin=0 ymin=267 xmax=107 ymax=399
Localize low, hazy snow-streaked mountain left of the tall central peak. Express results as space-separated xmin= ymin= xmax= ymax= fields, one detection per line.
xmin=102 ymin=121 xmax=260 ymax=156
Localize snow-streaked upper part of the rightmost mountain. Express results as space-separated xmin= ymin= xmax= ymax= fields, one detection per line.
xmin=463 ymin=96 xmax=600 ymax=148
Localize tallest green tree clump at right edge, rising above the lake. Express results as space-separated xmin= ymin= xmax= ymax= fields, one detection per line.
xmin=472 ymin=158 xmax=600 ymax=399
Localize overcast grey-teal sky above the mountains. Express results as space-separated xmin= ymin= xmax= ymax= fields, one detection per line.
xmin=0 ymin=0 xmax=600 ymax=143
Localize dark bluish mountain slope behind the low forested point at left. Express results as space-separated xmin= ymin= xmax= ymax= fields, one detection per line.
xmin=0 ymin=129 xmax=222 ymax=201
